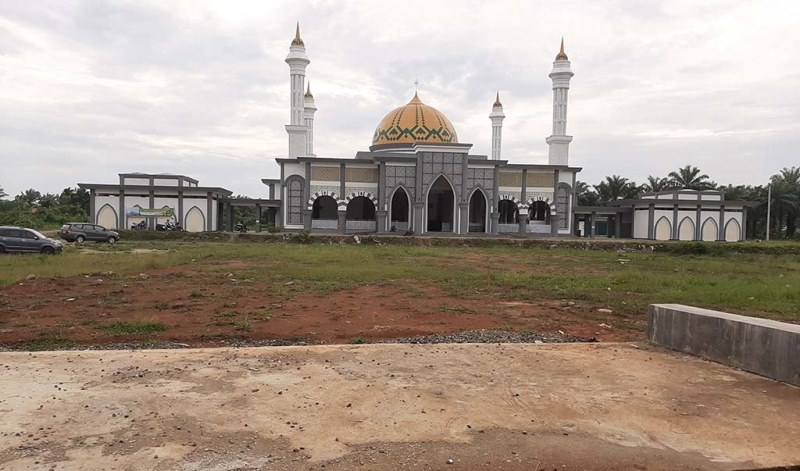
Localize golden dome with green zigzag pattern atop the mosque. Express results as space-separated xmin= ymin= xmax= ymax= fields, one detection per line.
xmin=372 ymin=93 xmax=458 ymax=145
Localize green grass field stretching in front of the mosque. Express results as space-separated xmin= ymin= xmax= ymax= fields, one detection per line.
xmin=0 ymin=241 xmax=800 ymax=321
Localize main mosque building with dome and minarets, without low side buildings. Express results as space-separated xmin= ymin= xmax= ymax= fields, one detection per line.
xmin=263 ymin=25 xmax=581 ymax=236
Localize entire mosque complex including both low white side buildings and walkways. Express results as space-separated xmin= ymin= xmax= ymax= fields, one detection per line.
xmin=79 ymin=25 xmax=755 ymax=241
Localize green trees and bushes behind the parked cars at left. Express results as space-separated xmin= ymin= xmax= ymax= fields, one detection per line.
xmin=0 ymin=187 xmax=89 ymax=230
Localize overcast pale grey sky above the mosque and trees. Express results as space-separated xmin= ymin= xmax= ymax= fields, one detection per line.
xmin=0 ymin=0 xmax=800 ymax=197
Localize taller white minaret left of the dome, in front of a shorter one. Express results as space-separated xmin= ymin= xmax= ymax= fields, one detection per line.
xmin=286 ymin=22 xmax=311 ymax=158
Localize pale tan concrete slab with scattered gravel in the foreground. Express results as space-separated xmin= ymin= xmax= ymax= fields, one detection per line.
xmin=0 ymin=344 xmax=800 ymax=471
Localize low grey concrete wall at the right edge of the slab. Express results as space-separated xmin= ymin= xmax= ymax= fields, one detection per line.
xmin=647 ymin=304 xmax=800 ymax=386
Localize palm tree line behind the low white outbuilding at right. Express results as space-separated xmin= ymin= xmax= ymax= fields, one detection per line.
xmin=575 ymin=165 xmax=800 ymax=239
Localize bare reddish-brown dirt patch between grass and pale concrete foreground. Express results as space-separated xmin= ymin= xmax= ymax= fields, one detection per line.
xmin=0 ymin=261 xmax=642 ymax=347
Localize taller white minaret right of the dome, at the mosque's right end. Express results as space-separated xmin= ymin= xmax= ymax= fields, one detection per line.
xmin=545 ymin=38 xmax=575 ymax=165
